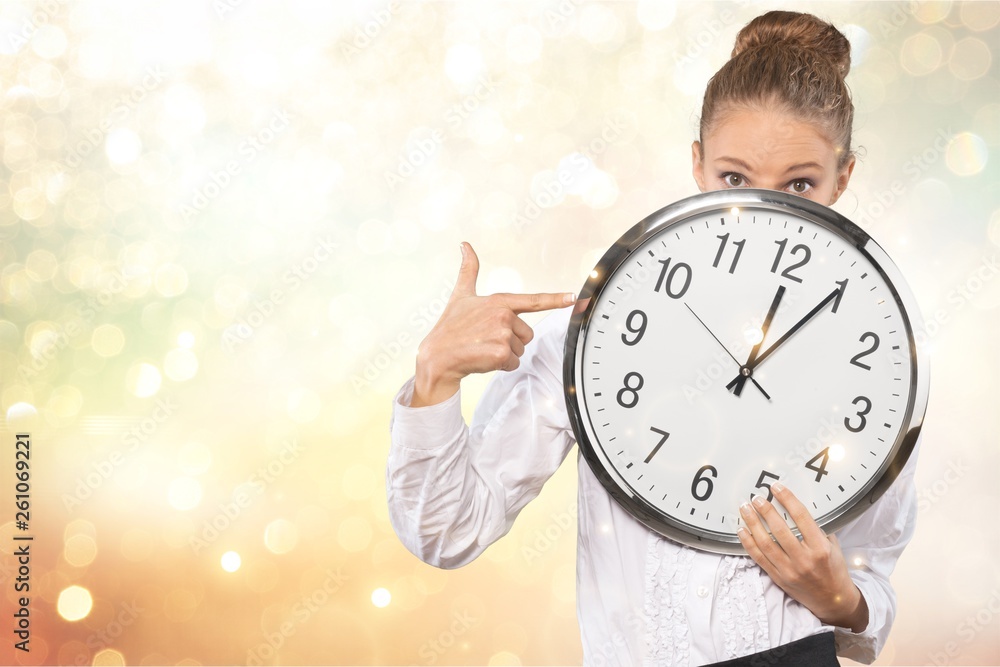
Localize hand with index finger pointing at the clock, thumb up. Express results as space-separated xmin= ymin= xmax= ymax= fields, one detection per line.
xmin=410 ymin=242 xmax=576 ymax=408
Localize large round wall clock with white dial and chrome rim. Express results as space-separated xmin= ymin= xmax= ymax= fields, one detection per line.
xmin=565 ymin=189 xmax=927 ymax=553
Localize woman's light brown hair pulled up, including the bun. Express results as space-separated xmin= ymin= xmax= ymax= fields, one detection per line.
xmin=699 ymin=11 xmax=854 ymax=167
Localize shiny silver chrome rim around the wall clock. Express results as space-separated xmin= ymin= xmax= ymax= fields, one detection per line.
xmin=563 ymin=188 xmax=930 ymax=555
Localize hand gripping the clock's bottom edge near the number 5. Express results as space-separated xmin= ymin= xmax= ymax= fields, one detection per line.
xmin=738 ymin=482 xmax=868 ymax=632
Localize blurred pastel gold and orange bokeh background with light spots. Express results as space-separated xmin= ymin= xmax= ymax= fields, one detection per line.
xmin=0 ymin=0 xmax=1000 ymax=665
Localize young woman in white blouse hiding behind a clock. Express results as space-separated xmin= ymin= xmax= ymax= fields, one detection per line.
xmin=387 ymin=12 xmax=916 ymax=667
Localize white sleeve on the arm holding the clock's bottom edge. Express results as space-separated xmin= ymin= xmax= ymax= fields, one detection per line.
xmin=834 ymin=437 xmax=920 ymax=665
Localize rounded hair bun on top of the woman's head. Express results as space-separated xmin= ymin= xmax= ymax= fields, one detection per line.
xmin=732 ymin=11 xmax=851 ymax=77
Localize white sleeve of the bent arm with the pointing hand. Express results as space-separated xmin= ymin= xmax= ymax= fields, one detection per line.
xmin=386 ymin=308 xmax=574 ymax=568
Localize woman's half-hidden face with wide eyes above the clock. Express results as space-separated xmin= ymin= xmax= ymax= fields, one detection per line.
xmin=691 ymin=107 xmax=854 ymax=206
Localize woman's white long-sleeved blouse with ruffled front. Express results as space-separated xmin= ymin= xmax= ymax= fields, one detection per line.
xmin=386 ymin=307 xmax=919 ymax=667
